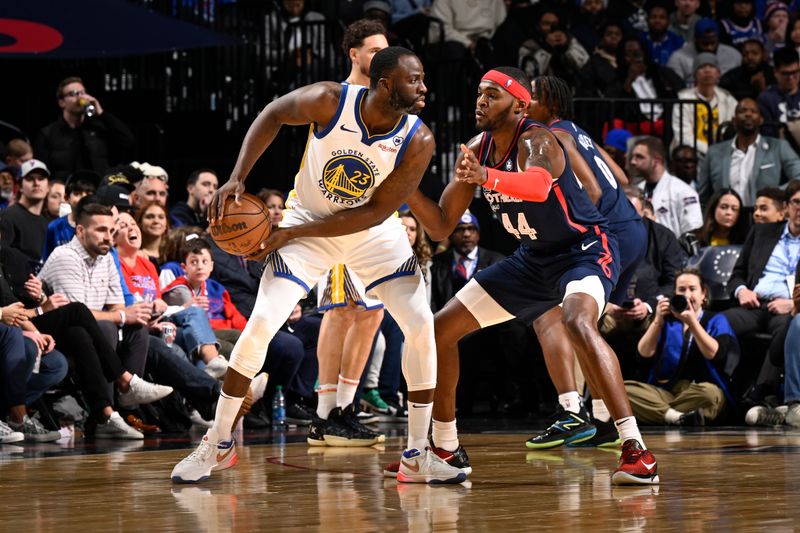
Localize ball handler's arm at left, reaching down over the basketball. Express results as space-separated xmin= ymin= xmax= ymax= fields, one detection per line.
xmin=208 ymin=81 xmax=342 ymax=221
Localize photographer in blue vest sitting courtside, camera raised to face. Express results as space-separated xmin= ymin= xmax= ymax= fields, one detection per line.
xmin=625 ymin=268 xmax=739 ymax=425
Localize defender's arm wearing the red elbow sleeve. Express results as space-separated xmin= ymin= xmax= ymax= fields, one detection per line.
xmin=456 ymin=127 xmax=566 ymax=202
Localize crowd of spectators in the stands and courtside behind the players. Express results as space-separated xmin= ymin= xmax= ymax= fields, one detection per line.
xmin=0 ymin=0 xmax=800 ymax=442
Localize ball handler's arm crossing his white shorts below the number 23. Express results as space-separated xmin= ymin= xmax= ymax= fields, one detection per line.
xmin=261 ymin=125 xmax=435 ymax=255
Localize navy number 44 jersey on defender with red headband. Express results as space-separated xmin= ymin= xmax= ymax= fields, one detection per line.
xmin=478 ymin=119 xmax=606 ymax=252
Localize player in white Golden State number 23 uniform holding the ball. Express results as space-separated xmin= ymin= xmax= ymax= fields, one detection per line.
xmin=171 ymin=47 xmax=466 ymax=483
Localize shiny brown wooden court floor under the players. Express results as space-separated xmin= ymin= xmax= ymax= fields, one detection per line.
xmin=0 ymin=429 xmax=800 ymax=533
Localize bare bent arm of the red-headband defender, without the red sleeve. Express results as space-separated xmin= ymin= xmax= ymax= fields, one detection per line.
xmin=408 ymin=135 xmax=481 ymax=241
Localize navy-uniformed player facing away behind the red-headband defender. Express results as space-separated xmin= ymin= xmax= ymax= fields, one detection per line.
xmin=527 ymin=76 xmax=647 ymax=448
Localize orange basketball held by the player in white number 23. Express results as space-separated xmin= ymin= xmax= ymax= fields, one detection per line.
xmin=208 ymin=193 xmax=272 ymax=256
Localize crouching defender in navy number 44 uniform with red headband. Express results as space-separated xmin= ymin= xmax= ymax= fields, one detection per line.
xmin=408 ymin=67 xmax=658 ymax=484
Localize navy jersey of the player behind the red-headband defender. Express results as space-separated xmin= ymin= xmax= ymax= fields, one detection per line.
xmin=550 ymin=120 xmax=640 ymax=224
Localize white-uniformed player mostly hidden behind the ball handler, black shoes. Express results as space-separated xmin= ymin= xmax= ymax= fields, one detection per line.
xmin=307 ymin=19 xmax=389 ymax=446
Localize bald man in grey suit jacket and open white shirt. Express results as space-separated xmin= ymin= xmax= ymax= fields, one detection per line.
xmin=697 ymin=98 xmax=800 ymax=207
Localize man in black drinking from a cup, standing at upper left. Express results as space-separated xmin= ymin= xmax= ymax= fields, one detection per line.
xmin=34 ymin=76 xmax=135 ymax=181
